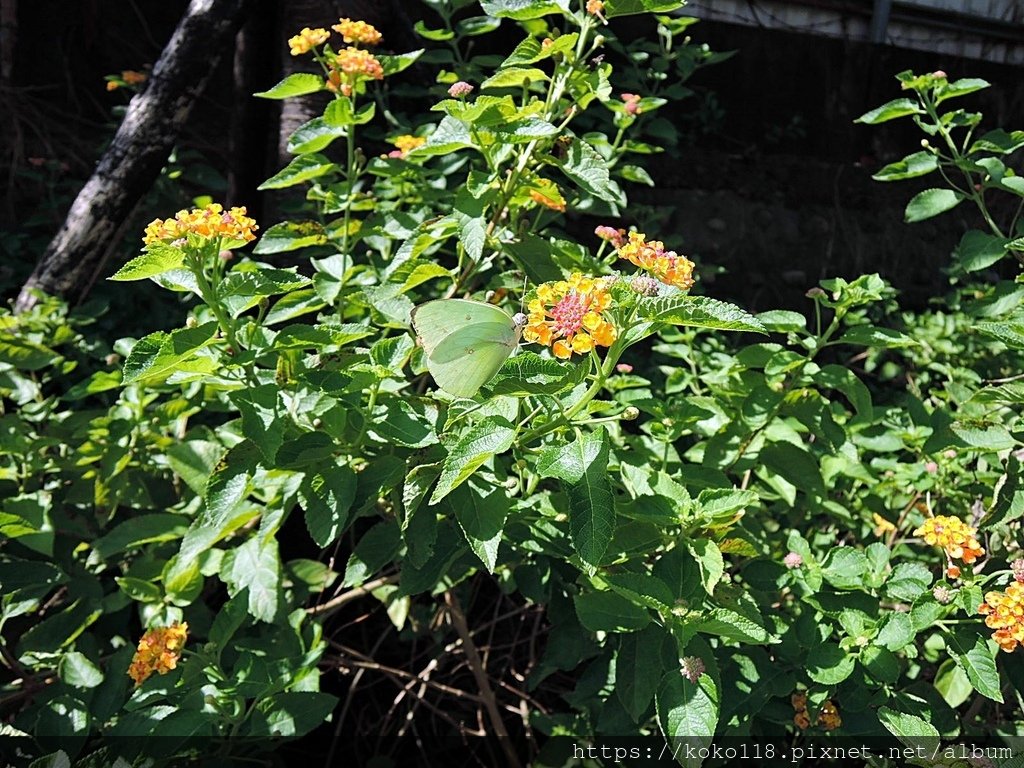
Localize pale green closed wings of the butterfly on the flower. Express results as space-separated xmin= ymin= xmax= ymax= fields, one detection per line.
xmin=413 ymin=299 xmax=522 ymax=397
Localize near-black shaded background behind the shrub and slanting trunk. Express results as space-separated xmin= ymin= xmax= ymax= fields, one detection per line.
xmin=0 ymin=0 xmax=1024 ymax=309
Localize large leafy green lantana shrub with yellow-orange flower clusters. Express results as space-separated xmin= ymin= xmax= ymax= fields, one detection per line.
xmin=6 ymin=0 xmax=1024 ymax=766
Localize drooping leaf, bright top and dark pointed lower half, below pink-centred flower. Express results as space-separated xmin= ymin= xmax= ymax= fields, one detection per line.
xmin=537 ymin=427 xmax=615 ymax=566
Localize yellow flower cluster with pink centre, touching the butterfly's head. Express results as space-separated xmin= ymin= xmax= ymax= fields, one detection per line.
xmin=522 ymin=272 xmax=616 ymax=359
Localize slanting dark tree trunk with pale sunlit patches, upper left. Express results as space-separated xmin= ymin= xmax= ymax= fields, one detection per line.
xmin=15 ymin=0 xmax=249 ymax=311
